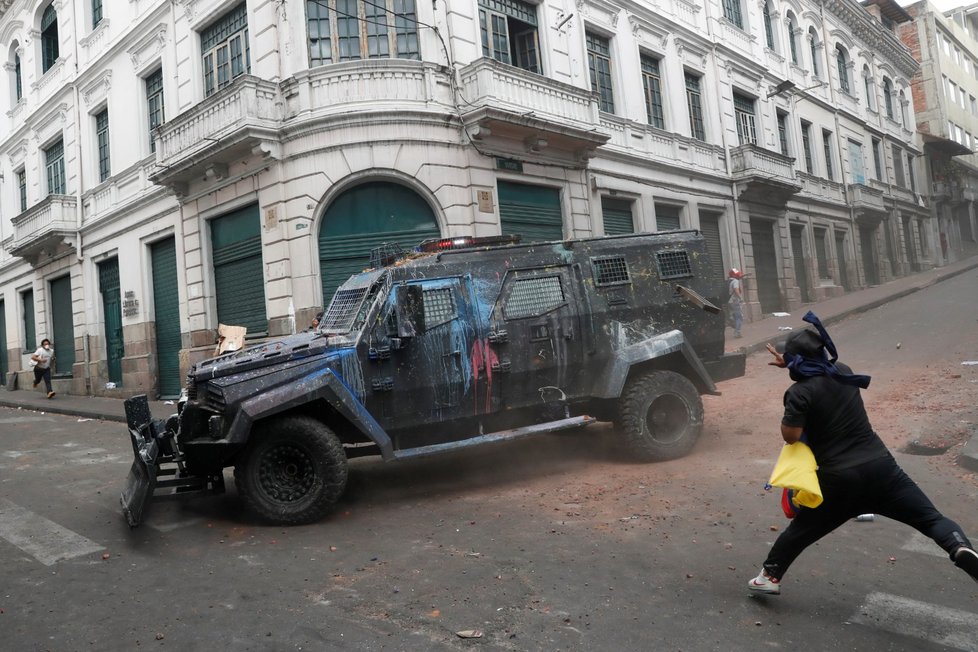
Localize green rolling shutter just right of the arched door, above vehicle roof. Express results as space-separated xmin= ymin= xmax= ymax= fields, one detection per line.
xmin=499 ymin=181 xmax=564 ymax=242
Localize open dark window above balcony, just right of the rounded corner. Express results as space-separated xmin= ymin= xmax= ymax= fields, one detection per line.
xmin=479 ymin=0 xmax=543 ymax=73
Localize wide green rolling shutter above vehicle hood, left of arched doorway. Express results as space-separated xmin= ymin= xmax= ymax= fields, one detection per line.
xmin=211 ymin=204 xmax=268 ymax=335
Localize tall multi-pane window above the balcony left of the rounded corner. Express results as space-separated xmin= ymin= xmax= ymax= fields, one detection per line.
xmin=200 ymin=2 xmax=251 ymax=97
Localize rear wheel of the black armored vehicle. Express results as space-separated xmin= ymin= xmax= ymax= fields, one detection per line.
xmin=615 ymin=371 xmax=703 ymax=462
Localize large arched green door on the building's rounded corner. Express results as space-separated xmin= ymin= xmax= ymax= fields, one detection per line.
xmin=319 ymin=181 xmax=441 ymax=305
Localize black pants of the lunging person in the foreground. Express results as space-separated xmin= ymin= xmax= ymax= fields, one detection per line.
xmin=764 ymin=456 xmax=971 ymax=579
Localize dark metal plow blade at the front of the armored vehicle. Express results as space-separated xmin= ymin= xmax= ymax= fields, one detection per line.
xmin=120 ymin=395 xmax=160 ymax=527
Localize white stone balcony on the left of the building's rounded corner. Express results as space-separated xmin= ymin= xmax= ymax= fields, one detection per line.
xmin=156 ymin=75 xmax=280 ymax=168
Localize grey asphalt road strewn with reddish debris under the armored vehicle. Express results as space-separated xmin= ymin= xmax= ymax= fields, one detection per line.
xmin=0 ymin=271 xmax=978 ymax=652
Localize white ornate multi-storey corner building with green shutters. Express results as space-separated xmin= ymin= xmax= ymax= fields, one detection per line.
xmin=0 ymin=0 xmax=935 ymax=396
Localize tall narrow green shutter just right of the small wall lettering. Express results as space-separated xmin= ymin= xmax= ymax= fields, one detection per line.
xmin=150 ymin=238 xmax=182 ymax=398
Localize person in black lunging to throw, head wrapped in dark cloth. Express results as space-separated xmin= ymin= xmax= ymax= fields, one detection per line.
xmin=747 ymin=312 xmax=978 ymax=594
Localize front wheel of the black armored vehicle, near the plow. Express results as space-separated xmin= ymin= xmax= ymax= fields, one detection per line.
xmin=234 ymin=416 xmax=347 ymax=525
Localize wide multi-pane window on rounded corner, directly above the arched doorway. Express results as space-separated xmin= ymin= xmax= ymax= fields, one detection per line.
xmin=306 ymin=0 xmax=421 ymax=66
